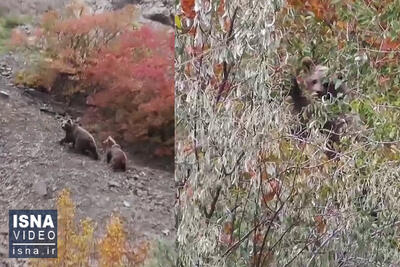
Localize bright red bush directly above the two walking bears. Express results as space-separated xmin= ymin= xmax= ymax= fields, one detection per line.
xmin=83 ymin=26 xmax=174 ymax=153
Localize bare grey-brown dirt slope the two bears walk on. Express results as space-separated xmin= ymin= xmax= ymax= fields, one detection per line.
xmin=0 ymin=52 xmax=175 ymax=266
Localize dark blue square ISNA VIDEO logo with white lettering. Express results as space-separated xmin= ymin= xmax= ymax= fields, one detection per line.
xmin=8 ymin=210 xmax=57 ymax=258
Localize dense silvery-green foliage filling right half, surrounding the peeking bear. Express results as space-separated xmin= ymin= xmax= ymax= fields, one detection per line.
xmin=175 ymin=0 xmax=400 ymax=267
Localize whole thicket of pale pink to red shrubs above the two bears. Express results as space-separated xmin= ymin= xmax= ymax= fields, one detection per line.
xmin=11 ymin=1 xmax=174 ymax=155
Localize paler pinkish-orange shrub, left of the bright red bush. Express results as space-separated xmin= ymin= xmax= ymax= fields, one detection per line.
xmin=42 ymin=4 xmax=136 ymax=76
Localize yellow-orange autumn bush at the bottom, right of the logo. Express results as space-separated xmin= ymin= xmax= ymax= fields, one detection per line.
xmin=30 ymin=189 xmax=150 ymax=267
